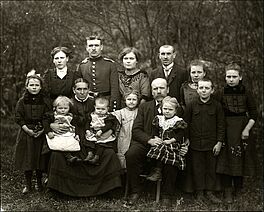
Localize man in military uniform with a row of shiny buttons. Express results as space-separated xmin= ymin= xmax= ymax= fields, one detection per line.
xmin=75 ymin=36 xmax=120 ymax=111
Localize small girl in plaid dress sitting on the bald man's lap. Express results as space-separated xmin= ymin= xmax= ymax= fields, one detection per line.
xmin=147 ymin=96 xmax=187 ymax=181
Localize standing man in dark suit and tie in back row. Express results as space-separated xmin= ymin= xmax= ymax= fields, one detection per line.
xmin=150 ymin=45 xmax=188 ymax=115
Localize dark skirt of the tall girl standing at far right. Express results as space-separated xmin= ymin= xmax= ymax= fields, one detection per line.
xmin=216 ymin=116 xmax=257 ymax=176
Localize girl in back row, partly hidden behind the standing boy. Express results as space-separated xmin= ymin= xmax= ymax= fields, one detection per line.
xmin=180 ymin=60 xmax=206 ymax=109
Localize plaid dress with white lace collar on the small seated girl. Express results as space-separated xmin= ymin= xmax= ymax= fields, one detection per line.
xmin=147 ymin=115 xmax=187 ymax=170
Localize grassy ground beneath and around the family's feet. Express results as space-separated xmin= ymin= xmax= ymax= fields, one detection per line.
xmin=1 ymin=118 xmax=263 ymax=211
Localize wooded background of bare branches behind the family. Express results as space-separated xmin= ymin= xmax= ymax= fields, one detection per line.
xmin=1 ymin=0 xmax=263 ymax=116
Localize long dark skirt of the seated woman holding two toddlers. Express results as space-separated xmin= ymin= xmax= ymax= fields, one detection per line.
xmin=48 ymin=148 xmax=121 ymax=197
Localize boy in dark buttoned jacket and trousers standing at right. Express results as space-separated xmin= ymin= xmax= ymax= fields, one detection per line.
xmin=184 ymin=78 xmax=225 ymax=203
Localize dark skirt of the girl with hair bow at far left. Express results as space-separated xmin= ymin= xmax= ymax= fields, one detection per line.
xmin=15 ymin=129 xmax=46 ymax=171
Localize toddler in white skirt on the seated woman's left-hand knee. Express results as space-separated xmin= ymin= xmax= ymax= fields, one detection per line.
xmin=44 ymin=96 xmax=81 ymax=163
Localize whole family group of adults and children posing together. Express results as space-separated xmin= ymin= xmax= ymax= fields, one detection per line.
xmin=11 ymin=35 xmax=258 ymax=208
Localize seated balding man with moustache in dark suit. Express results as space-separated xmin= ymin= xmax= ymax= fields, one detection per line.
xmin=126 ymin=78 xmax=188 ymax=207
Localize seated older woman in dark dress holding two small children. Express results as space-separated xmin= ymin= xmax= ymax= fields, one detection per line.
xmin=47 ymin=78 xmax=121 ymax=197
